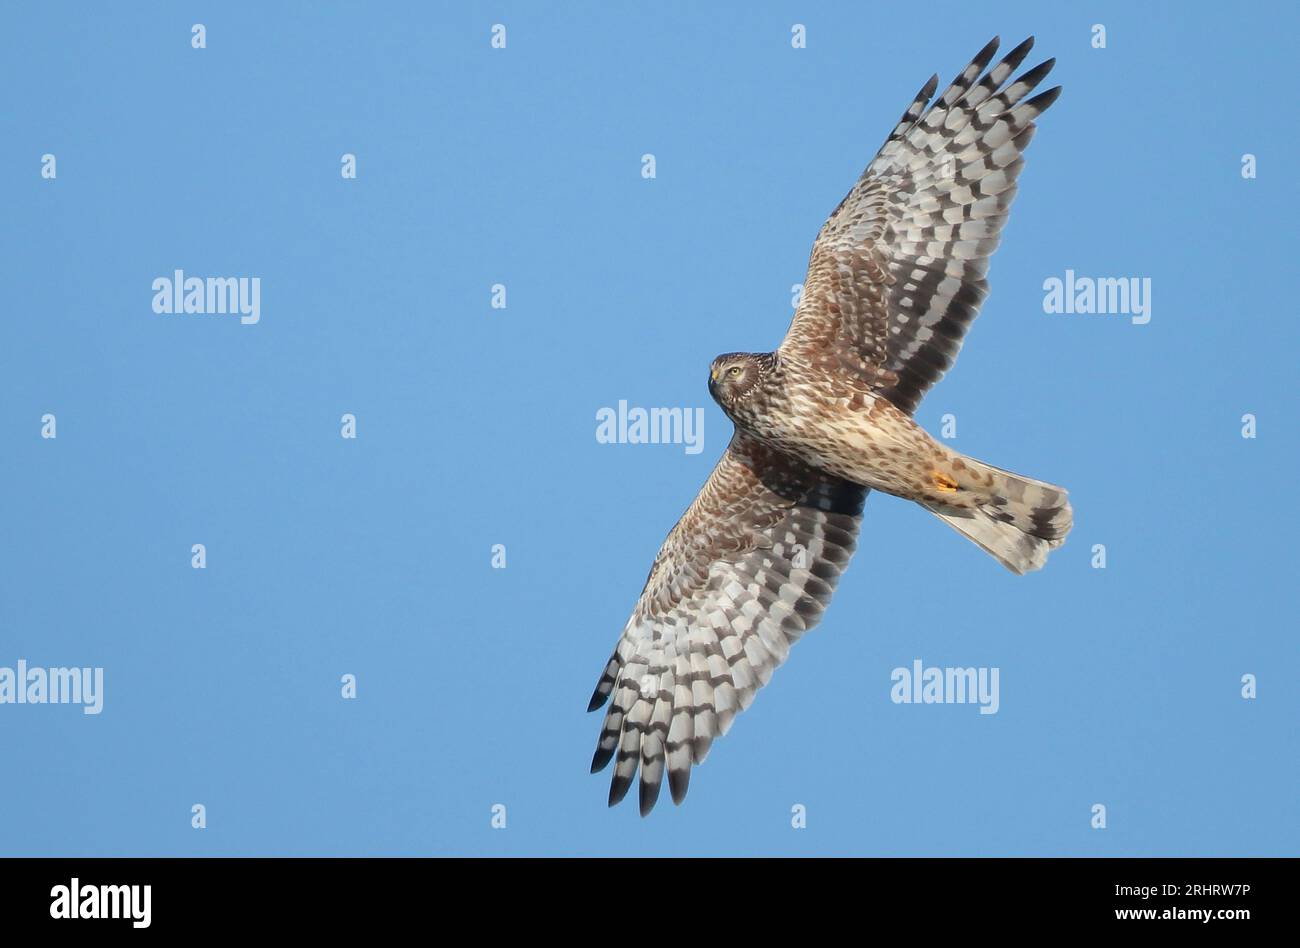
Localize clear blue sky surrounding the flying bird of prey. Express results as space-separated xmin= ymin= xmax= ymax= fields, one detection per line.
xmin=0 ymin=3 xmax=1300 ymax=856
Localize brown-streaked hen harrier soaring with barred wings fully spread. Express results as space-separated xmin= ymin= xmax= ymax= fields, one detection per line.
xmin=589 ymin=38 xmax=1071 ymax=815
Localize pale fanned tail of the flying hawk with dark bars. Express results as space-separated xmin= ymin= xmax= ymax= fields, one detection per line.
xmin=924 ymin=458 xmax=1074 ymax=573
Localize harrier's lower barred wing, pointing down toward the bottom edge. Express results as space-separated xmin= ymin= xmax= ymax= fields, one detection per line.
xmin=588 ymin=432 xmax=867 ymax=815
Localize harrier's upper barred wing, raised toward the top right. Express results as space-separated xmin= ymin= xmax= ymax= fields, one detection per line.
xmin=780 ymin=36 xmax=1061 ymax=412
